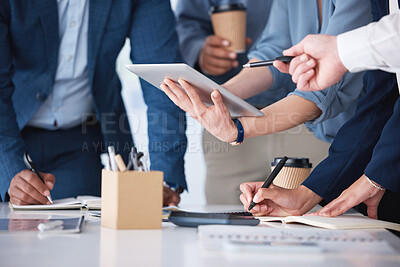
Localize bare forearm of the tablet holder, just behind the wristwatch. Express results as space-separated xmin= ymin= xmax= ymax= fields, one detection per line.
xmin=241 ymin=95 xmax=321 ymax=138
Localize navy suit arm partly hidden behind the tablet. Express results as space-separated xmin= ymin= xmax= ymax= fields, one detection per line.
xmin=130 ymin=0 xmax=187 ymax=193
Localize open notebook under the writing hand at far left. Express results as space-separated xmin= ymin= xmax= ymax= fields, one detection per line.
xmin=10 ymin=196 xmax=101 ymax=210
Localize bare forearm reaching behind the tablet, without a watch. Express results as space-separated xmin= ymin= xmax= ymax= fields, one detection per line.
xmin=223 ymin=58 xmax=274 ymax=99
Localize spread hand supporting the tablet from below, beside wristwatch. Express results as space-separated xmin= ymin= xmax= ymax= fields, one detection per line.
xmin=160 ymin=79 xmax=237 ymax=142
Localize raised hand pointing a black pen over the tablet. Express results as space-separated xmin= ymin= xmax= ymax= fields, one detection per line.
xmin=274 ymin=34 xmax=347 ymax=91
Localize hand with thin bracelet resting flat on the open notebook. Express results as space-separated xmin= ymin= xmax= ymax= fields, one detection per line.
xmin=310 ymin=174 xmax=385 ymax=219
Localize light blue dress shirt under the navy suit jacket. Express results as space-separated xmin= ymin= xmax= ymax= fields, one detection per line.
xmin=28 ymin=0 xmax=93 ymax=130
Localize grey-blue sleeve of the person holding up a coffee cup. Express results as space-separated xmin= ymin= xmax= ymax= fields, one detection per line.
xmin=175 ymin=0 xmax=213 ymax=67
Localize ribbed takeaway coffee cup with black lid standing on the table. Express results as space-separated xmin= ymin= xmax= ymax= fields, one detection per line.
xmin=271 ymin=158 xmax=312 ymax=189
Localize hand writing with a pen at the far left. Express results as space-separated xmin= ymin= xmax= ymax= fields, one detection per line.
xmin=9 ymin=170 xmax=56 ymax=205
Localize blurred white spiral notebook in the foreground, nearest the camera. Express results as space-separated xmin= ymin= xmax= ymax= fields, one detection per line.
xmin=198 ymin=225 xmax=395 ymax=254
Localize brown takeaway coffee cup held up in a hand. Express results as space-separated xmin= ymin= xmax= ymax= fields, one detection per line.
xmin=210 ymin=4 xmax=246 ymax=53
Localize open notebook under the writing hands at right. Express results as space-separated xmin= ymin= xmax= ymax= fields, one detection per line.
xmin=257 ymin=215 xmax=400 ymax=231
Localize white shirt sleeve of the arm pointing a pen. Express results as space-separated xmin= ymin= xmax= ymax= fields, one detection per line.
xmin=337 ymin=13 xmax=400 ymax=73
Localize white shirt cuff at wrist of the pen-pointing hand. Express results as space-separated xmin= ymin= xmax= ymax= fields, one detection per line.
xmin=337 ymin=26 xmax=374 ymax=72
